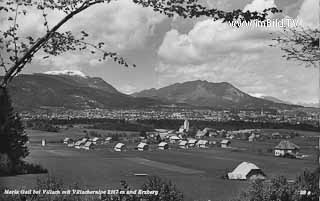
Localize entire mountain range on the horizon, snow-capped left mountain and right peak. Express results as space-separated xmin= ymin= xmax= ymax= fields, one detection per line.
xmin=5 ymin=71 xmax=301 ymax=110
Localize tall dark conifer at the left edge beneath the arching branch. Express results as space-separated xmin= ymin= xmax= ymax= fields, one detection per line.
xmin=0 ymin=87 xmax=29 ymax=172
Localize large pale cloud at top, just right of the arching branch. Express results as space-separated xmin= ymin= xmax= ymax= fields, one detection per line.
xmin=62 ymin=0 xmax=165 ymax=51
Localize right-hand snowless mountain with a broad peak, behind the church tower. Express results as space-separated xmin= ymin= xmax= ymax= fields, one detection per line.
xmin=131 ymin=80 xmax=299 ymax=109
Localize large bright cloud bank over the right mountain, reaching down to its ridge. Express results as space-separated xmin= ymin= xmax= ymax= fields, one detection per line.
xmin=155 ymin=0 xmax=317 ymax=101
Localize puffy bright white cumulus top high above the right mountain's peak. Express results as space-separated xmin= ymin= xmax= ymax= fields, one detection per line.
xmin=158 ymin=19 xmax=271 ymax=63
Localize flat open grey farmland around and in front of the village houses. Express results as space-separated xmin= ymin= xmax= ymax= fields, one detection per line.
xmin=0 ymin=130 xmax=317 ymax=201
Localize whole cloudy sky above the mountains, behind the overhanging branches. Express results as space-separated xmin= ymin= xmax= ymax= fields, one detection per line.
xmin=0 ymin=0 xmax=320 ymax=103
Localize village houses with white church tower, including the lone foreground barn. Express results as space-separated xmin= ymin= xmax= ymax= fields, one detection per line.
xmin=42 ymin=120 xmax=309 ymax=180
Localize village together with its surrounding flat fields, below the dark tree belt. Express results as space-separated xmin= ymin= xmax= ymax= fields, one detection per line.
xmin=5 ymin=119 xmax=318 ymax=201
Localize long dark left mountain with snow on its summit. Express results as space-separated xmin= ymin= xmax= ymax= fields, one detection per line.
xmin=9 ymin=74 xmax=161 ymax=110
